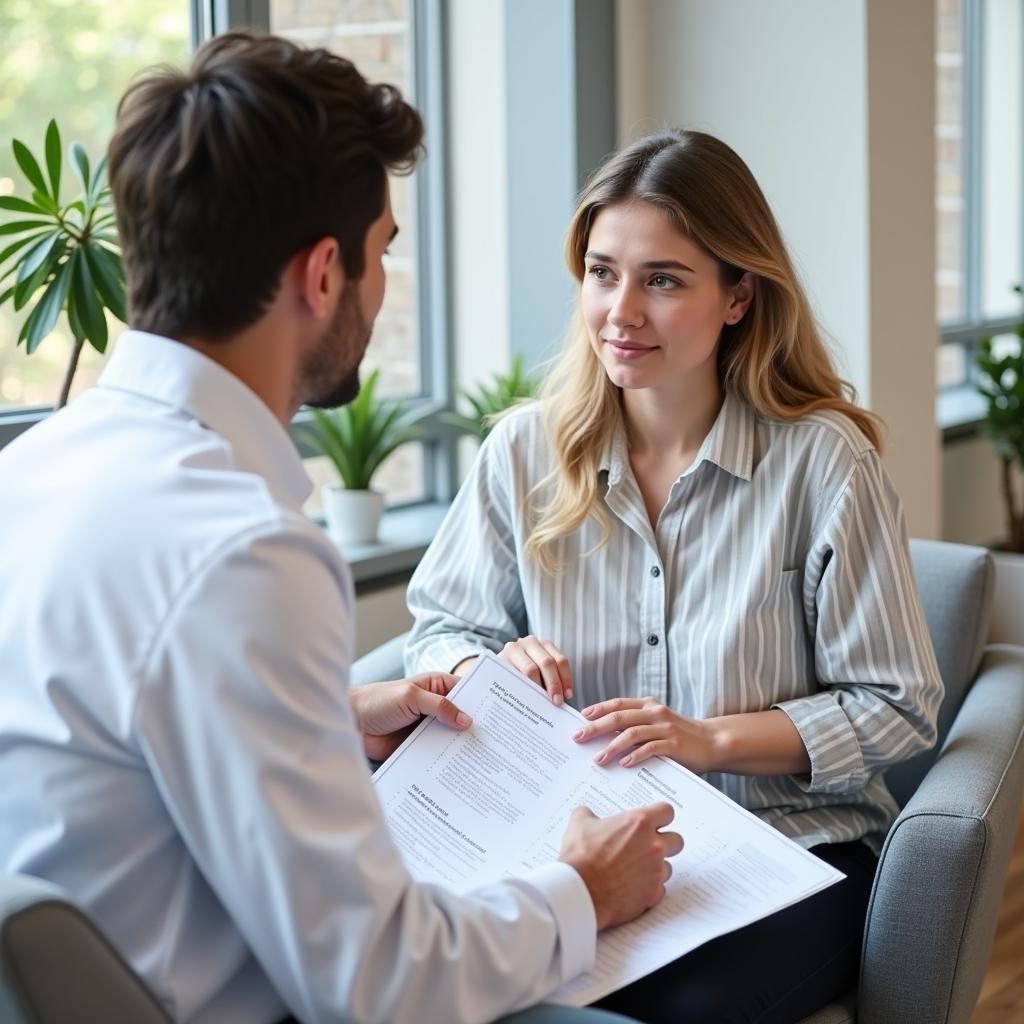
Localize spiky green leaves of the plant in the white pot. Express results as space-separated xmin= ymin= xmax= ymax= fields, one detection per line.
xmin=306 ymin=370 xmax=423 ymax=490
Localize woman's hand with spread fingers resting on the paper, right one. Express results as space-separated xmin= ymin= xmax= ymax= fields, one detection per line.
xmin=572 ymin=697 xmax=718 ymax=774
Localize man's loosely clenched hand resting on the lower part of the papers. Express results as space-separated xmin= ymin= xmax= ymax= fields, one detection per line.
xmin=559 ymin=804 xmax=683 ymax=931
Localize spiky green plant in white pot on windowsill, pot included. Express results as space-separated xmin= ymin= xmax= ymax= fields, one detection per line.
xmin=306 ymin=370 xmax=422 ymax=544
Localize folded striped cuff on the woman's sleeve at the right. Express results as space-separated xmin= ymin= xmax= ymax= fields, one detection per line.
xmin=772 ymin=692 xmax=867 ymax=794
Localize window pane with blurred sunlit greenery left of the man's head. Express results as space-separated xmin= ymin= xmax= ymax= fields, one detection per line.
xmin=0 ymin=0 xmax=189 ymax=408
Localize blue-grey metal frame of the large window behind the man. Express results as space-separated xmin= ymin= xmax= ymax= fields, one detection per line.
xmin=0 ymin=0 xmax=460 ymax=505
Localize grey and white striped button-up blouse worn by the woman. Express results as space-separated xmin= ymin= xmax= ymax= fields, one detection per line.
xmin=406 ymin=393 xmax=942 ymax=852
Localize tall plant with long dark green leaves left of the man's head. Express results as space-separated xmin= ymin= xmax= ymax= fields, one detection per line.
xmin=0 ymin=121 xmax=126 ymax=409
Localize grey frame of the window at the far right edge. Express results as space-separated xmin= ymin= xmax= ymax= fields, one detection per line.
xmin=937 ymin=0 xmax=1024 ymax=440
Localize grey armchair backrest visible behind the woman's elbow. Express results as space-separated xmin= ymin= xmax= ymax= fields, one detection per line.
xmin=886 ymin=540 xmax=995 ymax=807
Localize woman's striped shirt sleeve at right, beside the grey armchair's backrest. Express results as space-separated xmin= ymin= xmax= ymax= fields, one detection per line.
xmin=774 ymin=451 xmax=943 ymax=794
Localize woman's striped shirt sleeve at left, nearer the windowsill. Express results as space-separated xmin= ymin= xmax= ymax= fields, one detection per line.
xmin=406 ymin=421 xmax=528 ymax=674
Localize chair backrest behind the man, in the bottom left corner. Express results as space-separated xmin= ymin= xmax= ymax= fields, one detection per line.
xmin=0 ymin=873 xmax=171 ymax=1024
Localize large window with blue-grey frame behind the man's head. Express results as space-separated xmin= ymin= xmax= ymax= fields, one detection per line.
xmin=0 ymin=0 xmax=455 ymax=513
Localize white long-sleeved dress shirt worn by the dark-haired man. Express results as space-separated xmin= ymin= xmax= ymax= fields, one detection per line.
xmin=0 ymin=332 xmax=595 ymax=1024
